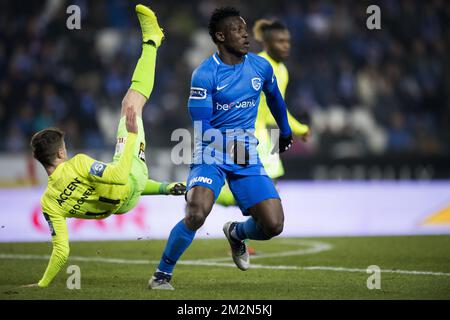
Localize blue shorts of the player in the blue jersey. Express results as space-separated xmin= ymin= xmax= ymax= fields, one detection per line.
xmin=186 ymin=164 xmax=280 ymax=215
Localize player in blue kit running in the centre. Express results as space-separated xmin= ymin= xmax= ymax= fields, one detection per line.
xmin=149 ymin=7 xmax=292 ymax=290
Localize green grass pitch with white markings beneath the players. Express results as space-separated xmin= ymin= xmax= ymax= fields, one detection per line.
xmin=0 ymin=236 xmax=450 ymax=300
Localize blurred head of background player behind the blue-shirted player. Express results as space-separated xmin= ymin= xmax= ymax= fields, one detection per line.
xmin=253 ymin=19 xmax=291 ymax=61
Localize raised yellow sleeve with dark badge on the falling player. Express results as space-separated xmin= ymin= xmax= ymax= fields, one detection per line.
xmin=73 ymin=132 xmax=137 ymax=185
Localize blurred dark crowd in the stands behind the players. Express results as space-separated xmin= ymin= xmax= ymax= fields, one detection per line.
xmin=0 ymin=0 xmax=450 ymax=157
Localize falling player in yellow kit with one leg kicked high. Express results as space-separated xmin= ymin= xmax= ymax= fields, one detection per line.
xmin=23 ymin=5 xmax=185 ymax=287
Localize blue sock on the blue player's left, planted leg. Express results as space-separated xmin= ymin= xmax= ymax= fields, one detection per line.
xmin=157 ymin=219 xmax=195 ymax=274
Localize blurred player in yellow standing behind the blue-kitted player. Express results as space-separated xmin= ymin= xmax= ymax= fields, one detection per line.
xmin=216 ymin=19 xmax=310 ymax=206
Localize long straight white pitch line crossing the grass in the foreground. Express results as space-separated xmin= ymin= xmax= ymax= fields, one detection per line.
xmin=0 ymin=254 xmax=450 ymax=277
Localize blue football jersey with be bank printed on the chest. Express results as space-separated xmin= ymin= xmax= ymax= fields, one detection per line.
xmin=188 ymin=53 xmax=277 ymax=171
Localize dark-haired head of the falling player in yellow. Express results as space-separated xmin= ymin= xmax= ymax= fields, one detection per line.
xmin=30 ymin=128 xmax=64 ymax=168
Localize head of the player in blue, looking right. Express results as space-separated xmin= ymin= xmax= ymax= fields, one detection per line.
xmin=208 ymin=7 xmax=250 ymax=56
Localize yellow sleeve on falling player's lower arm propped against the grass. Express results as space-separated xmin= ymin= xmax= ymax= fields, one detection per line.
xmin=38 ymin=212 xmax=69 ymax=287
